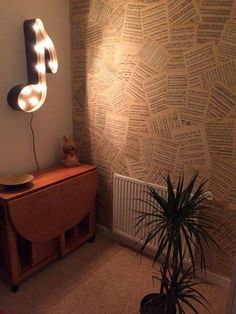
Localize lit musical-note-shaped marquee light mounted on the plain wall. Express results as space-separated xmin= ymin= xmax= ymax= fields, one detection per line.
xmin=7 ymin=18 xmax=58 ymax=112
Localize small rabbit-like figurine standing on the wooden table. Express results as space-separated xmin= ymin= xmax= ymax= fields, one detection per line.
xmin=62 ymin=135 xmax=80 ymax=167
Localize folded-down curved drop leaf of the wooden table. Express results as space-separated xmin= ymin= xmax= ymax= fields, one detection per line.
xmin=8 ymin=170 xmax=98 ymax=242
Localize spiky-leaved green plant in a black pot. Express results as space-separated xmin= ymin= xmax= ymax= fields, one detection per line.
xmin=136 ymin=173 xmax=220 ymax=314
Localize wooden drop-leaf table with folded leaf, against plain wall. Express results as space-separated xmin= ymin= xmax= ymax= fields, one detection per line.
xmin=0 ymin=164 xmax=98 ymax=291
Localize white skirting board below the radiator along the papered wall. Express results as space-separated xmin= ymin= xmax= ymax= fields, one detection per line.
xmin=96 ymin=224 xmax=230 ymax=289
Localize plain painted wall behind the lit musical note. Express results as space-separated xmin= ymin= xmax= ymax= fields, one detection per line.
xmin=0 ymin=0 xmax=72 ymax=175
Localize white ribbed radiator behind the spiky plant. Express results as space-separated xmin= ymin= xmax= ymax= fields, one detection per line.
xmin=112 ymin=174 xmax=194 ymax=262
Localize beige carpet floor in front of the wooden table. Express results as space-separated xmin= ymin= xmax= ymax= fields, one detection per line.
xmin=0 ymin=236 xmax=228 ymax=314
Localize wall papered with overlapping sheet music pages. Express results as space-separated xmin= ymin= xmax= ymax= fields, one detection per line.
xmin=70 ymin=0 xmax=236 ymax=276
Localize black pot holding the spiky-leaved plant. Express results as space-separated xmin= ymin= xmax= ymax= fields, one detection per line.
xmin=140 ymin=293 xmax=176 ymax=314
